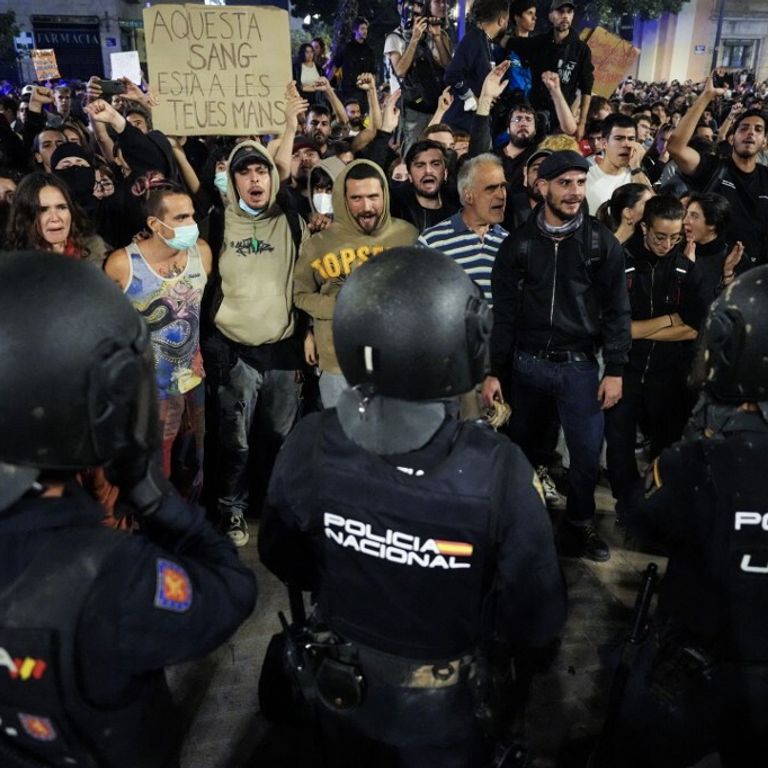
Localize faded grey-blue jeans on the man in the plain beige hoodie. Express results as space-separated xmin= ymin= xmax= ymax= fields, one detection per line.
xmin=217 ymin=358 xmax=301 ymax=518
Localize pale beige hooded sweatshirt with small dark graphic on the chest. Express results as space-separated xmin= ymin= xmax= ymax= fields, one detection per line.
xmin=215 ymin=141 xmax=309 ymax=347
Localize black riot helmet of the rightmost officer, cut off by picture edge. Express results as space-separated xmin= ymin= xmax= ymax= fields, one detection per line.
xmin=694 ymin=266 xmax=768 ymax=403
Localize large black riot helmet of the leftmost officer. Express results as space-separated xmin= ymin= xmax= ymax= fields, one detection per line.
xmin=0 ymin=252 xmax=158 ymax=503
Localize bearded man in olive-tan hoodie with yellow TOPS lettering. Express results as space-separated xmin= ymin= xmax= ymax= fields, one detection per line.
xmin=293 ymin=160 xmax=419 ymax=408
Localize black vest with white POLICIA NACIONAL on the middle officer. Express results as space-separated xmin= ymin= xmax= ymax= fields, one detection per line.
xmin=314 ymin=411 xmax=510 ymax=661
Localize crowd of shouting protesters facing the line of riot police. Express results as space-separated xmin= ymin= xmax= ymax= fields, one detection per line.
xmin=0 ymin=0 xmax=768 ymax=559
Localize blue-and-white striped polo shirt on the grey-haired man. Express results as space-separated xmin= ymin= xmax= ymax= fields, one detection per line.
xmin=418 ymin=211 xmax=509 ymax=305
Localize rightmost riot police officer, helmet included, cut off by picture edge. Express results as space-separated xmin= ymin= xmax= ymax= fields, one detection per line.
xmin=613 ymin=267 xmax=768 ymax=768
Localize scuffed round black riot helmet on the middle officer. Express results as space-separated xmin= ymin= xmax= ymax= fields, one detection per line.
xmin=333 ymin=247 xmax=492 ymax=401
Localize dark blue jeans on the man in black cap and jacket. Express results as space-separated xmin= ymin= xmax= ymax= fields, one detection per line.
xmin=508 ymin=351 xmax=603 ymax=525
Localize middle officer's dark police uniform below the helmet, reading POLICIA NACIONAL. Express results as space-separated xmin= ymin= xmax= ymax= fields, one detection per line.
xmin=259 ymin=410 xmax=565 ymax=768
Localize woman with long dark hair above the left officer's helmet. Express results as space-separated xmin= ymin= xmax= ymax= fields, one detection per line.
xmin=6 ymin=172 xmax=106 ymax=265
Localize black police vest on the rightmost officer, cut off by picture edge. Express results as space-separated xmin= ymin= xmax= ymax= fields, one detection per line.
xmin=668 ymin=427 xmax=768 ymax=663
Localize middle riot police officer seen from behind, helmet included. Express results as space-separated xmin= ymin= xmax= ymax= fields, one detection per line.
xmin=259 ymin=247 xmax=565 ymax=768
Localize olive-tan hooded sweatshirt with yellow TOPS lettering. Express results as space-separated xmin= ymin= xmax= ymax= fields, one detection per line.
xmin=293 ymin=160 xmax=419 ymax=373
